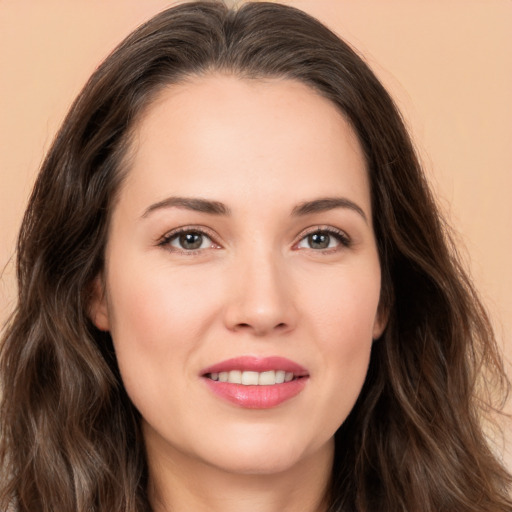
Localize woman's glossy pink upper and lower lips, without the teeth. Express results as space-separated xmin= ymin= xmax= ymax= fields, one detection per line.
xmin=201 ymin=356 xmax=309 ymax=409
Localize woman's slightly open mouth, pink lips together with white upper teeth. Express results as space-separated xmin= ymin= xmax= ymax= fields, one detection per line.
xmin=201 ymin=356 xmax=309 ymax=409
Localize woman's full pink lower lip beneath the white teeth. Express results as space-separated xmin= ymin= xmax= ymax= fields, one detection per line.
xmin=205 ymin=377 xmax=308 ymax=409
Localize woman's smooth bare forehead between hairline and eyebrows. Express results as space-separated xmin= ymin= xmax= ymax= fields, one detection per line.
xmin=118 ymin=75 xmax=370 ymax=216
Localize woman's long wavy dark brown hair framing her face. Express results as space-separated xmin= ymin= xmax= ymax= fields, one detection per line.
xmin=0 ymin=2 xmax=512 ymax=512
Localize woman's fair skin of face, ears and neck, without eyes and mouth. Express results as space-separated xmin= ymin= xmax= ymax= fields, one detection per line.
xmin=91 ymin=75 xmax=385 ymax=512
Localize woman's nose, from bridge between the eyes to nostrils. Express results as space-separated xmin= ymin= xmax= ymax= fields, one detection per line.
xmin=225 ymin=251 xmax=298 ymax=337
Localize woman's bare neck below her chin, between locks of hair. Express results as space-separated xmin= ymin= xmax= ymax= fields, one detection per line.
xmin=147 ymin=432 xmax=334 ymax=512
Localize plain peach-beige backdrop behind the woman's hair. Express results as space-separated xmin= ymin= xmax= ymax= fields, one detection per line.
xmin=0 ymin=0 xmax=512 ymax=467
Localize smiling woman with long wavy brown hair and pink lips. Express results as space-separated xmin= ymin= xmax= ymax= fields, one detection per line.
xmin=0 ymin=2 xmax=512 ymax=512
